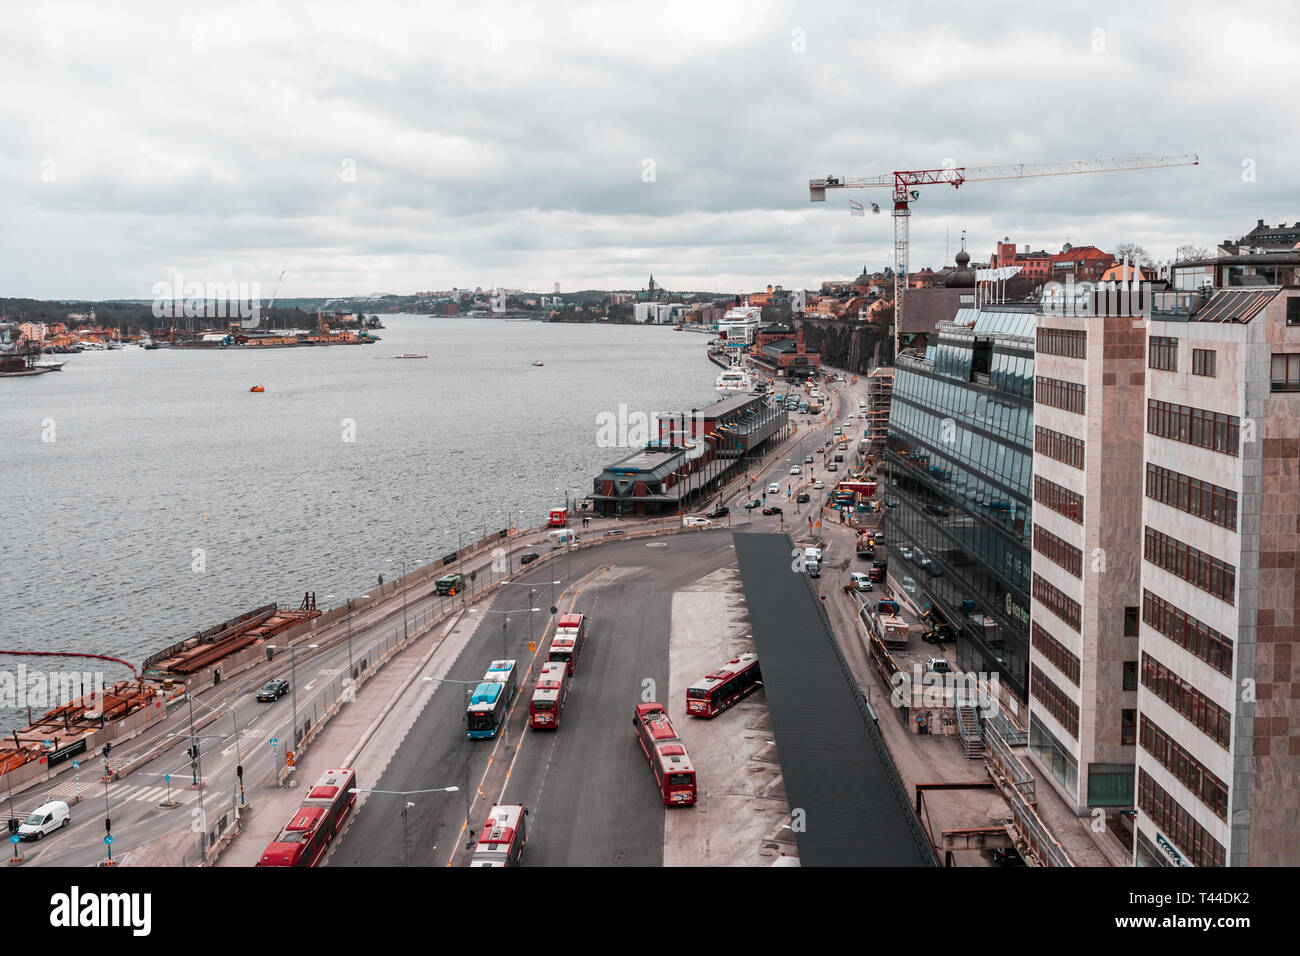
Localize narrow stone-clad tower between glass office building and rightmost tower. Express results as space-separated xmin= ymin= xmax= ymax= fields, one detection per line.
xmin=1028 ymin=291 xmax=1147 ymax=816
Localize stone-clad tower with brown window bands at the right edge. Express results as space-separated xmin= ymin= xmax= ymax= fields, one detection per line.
xmin=1133 ymin=282 xmax=1300 ymax=866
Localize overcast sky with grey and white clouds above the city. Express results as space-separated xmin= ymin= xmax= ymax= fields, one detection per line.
xmin=0 ymin=0 xmax=1300 ymax=299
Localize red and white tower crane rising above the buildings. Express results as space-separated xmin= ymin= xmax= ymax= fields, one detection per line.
xmin=809 ymin=152 xmax=1199 ymax=362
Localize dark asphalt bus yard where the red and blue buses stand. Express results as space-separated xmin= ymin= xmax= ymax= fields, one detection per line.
xmin=329 ymin=530 xmax=743 ymax=866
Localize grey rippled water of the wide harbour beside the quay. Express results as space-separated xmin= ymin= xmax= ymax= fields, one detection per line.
xmin=0 ymin=316 xmax=718 ymax=732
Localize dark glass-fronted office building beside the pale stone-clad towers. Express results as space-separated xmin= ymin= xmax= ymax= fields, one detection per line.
xmin=884 ymin=310 xmax=1037 ymax=701
